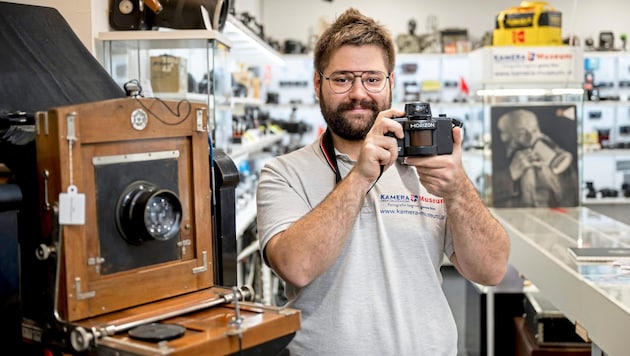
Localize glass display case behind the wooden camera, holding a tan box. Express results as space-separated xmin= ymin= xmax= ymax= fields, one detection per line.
xmin=97 ymin=30 xmax=232 ymax=151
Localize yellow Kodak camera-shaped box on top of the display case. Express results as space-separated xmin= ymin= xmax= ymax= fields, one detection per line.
xmin=492 ymin=1 xmax=562 ymax=46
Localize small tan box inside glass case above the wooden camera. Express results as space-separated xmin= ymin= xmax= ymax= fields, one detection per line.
xmin=151 ymin=54 xmax=188 ymax=93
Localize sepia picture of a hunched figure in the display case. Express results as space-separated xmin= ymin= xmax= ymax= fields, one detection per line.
xmin=490 ymin=104 xmax=580 ymax=208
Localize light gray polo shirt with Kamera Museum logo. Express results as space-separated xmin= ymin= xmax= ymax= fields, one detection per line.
xmin=257 ymin=139 xmax=457 ymax=356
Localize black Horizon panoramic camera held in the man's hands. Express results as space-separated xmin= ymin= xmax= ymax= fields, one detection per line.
xmin=388 ymin=103 xmax=463 ymax=157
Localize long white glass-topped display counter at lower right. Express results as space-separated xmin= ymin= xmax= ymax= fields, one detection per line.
xmin=493 ymin=207 xmax=630 ymax=355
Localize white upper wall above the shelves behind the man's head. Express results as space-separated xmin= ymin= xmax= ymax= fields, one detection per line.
xmin=249 ymin=0 xmax=630 ymax=51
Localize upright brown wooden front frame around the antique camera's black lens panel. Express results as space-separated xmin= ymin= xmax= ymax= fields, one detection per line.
xmin=36 ymin=98 xmax=214 ymax=321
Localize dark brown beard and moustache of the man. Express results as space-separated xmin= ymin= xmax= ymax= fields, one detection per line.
xmin=319 ymin=88 xmax=392 ymax=141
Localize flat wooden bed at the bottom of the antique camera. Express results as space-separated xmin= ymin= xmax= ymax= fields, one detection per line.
xmin=77 ymin=288 xmax=300 ymax=355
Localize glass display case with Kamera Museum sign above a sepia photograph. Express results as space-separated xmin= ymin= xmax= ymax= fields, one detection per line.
xmin=467 ymin=46 xmax=584 ymax=207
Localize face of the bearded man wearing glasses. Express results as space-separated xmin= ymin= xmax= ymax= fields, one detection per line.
xmin=314 ymin=45 xmax=393 ymax=140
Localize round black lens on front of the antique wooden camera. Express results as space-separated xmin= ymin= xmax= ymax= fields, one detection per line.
xmin=116 ymin=181 xmax=182 ymax=245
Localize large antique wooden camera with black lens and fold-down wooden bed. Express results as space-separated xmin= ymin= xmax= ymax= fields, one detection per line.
xmin=21 ymin=97 xmax=300 ymax=355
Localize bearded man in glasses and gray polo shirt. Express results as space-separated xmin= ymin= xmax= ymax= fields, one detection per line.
xmin=257 ymin=9 xmax=509 ymax=355
